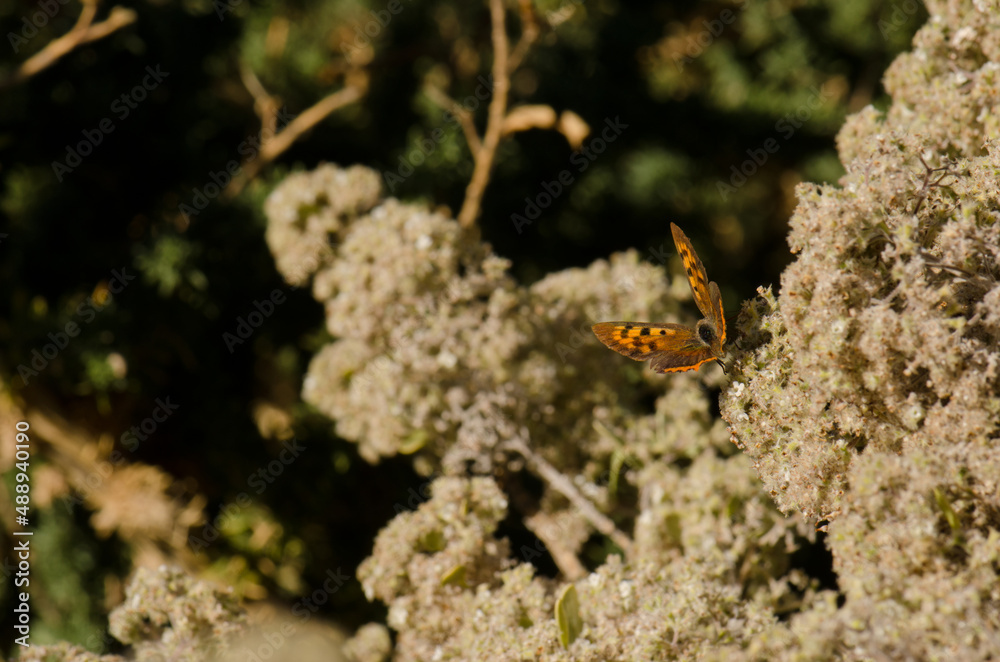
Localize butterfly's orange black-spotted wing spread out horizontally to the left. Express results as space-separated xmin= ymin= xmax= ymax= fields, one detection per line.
xmin=591 ymin=322 xmax=717 ymax=373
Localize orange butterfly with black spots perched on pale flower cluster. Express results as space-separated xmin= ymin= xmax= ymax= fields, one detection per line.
xmin=591 ymin=223 xmax=726 ymax=373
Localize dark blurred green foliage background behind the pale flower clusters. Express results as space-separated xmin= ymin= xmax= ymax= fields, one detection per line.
xmin=0 ymin=0 xmax=926 ymax=654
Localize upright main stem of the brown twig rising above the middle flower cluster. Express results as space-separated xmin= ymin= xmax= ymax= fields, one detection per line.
xmin=458 ymin=0 xmax=510 ymax=229
